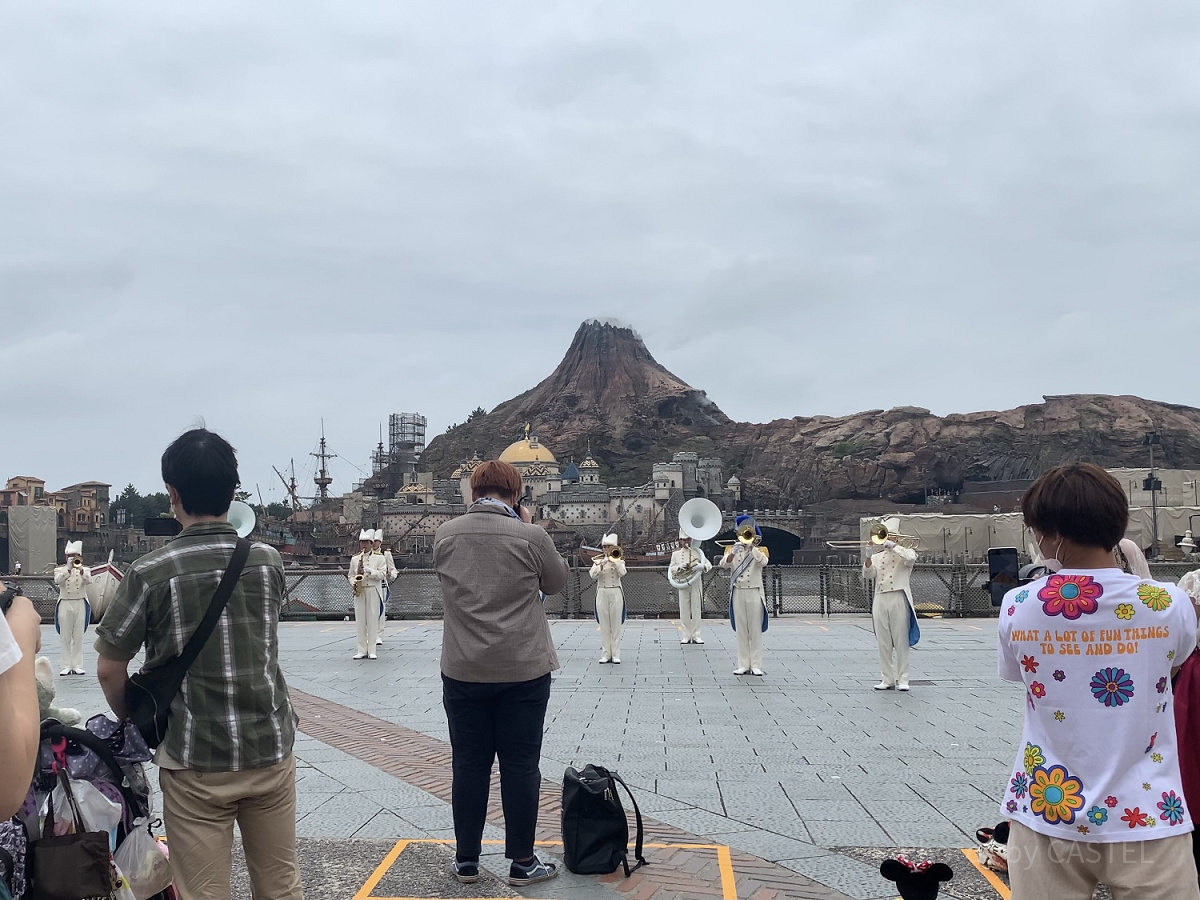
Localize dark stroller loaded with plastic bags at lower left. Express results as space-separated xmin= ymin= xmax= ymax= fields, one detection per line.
xmin=0 ymin=715 xmax=175 ymax=900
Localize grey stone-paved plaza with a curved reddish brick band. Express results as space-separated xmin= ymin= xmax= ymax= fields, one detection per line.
xmin=46 ymin=617 xmax=1022 ymax=900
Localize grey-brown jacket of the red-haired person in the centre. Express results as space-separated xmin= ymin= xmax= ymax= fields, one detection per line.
xmin=433 ymin=505 xmax=568 ymax=683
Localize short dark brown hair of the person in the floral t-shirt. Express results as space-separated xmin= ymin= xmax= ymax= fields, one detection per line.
xmin=1021 ymin=462 xmax=1129 ymax=550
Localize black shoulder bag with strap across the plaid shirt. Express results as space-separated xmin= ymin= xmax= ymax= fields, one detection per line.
xmin=125 ymin=538 xmax=250 ymax=749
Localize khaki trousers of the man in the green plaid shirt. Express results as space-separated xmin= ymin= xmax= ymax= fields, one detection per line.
xmin=158 ymin=755 xmax=304 ymax=900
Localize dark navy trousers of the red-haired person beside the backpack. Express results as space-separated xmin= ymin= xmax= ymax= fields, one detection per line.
xmin=442 ymin=672 xmax=550 ymax=859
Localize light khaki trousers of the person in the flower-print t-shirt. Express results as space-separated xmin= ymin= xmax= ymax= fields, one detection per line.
xmin=1008 ymin=822 xmax=1200 ymax=900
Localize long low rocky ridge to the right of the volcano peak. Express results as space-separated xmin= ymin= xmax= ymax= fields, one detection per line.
xmin=726 ymin=395 xmax=1200 ymax=506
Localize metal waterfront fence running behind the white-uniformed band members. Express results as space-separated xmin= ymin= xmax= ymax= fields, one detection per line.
xmin=8 ymin=563 xmax=1196 ymax=619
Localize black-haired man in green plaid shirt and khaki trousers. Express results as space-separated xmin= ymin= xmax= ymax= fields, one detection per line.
xmin=96 ymin=428 xmax=304 ymax=900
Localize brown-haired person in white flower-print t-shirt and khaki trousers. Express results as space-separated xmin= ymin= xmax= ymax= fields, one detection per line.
xmin=998 ymin=463 xmax=1200 ymax=900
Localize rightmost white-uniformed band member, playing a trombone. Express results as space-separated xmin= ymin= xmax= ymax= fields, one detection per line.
xmin=863 ymin=540 xmax=920 ymax=691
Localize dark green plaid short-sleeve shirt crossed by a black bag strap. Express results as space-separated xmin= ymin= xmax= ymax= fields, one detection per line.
xmin=96 ymin=522 xmax=296 ymax=772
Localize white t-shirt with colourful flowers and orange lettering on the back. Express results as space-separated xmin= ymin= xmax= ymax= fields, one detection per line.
xmin=998 ymin=569 xmax=1196 ymax=842
